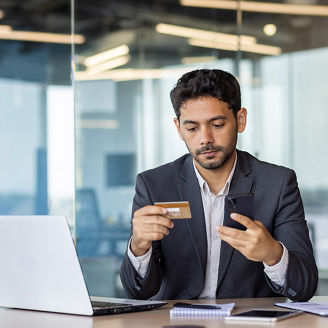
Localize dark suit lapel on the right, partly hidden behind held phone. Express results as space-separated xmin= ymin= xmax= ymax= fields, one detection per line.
xmin=218 ymin=151 xmax=253 ymax=288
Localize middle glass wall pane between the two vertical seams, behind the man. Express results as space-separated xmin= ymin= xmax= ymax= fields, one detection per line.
xmin=75 ymin=1 xmax=238 ymax=296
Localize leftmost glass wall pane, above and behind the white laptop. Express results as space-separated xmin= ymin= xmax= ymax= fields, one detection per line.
xmin=0 ymin=0 xmax=74 ymax=224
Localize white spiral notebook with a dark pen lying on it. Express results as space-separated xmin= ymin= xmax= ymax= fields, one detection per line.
xmin=170 ymin=302 xmax=235 ymax=317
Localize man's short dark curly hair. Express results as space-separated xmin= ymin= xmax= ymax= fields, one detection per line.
xmin=170 ymin=69 xmax=241 ymax=118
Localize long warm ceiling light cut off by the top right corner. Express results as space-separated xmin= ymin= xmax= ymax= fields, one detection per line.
xmin=180 ymin=0 xmax=328 ymax=16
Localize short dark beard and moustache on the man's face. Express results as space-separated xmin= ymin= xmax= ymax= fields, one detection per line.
xmin=186 ymin=131 xmax=237 ymax=170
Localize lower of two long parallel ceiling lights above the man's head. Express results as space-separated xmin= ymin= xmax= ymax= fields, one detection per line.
xmin=188 ymin=39 xmax=281 ymax=56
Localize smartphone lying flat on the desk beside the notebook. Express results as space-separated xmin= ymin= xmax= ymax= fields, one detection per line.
xmin=224 ymin=310 xmax=303 ymax=322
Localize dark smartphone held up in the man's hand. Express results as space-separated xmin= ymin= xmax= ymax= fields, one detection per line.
xmin=224 ymin=193 xmax=254 ymax=230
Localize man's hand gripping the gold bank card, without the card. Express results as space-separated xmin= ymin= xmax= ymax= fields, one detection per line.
xmin=130 ymin=205 xmax=174 ymax=256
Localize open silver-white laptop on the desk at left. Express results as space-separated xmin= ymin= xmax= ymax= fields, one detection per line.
xmin=0 ymin=215 xmax=167 ymax=316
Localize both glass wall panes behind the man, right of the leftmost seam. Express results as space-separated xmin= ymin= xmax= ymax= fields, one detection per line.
xmin=75 ymin=0 xmax=328 ymax=296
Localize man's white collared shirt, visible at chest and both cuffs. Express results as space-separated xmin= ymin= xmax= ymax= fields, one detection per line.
xmin=128 ymin=156 xmax=288 ymax=298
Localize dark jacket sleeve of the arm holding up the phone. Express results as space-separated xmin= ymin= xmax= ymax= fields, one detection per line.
xmin=267 ymin=170 xmax=318 ymax=301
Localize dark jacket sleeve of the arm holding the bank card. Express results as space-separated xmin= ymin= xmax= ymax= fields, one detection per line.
xmin=120 ymin=174 xmax=163 ymax=299
